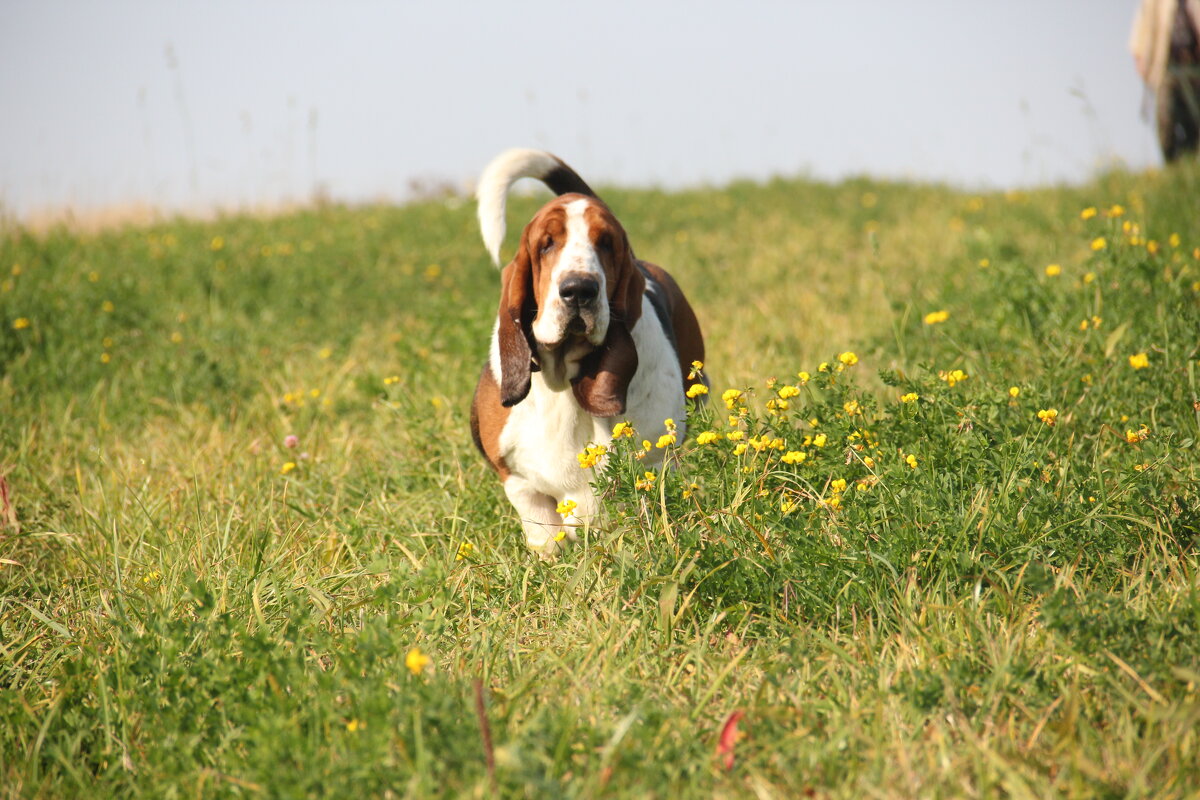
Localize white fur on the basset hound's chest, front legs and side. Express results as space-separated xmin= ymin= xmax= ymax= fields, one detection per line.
xmin=492 ymin=291 xmax=688 ymax=549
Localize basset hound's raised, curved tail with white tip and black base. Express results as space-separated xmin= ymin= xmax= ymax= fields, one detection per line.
xmin=475 ymin=148 xmax=596 ymax=266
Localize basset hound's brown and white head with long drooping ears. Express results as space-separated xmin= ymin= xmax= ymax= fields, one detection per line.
xmin=497 ymin=194 xmax=646 ymax=416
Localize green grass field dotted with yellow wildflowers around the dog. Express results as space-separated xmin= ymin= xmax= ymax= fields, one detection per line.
xmin=0 ymin=163 xmax=1200 ymax=798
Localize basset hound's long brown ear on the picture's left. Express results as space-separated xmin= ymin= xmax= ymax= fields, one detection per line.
xmin=497 ymin=236 xmax=538 ymax=407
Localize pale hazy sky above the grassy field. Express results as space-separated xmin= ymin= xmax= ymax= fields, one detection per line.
xmin=0 ymin=0 xmax=1159 ymax=216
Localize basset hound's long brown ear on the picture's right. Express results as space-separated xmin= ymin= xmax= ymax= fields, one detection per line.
xmin=571 ymin=233 xmax=646 ymax=416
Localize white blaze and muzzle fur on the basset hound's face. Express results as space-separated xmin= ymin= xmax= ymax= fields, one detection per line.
xmin=533 ymin=198 xmax=608 ymax=345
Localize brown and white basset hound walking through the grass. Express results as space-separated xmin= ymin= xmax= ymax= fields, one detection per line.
xmin=470 ymin=150 xmax=704 ymax=555
